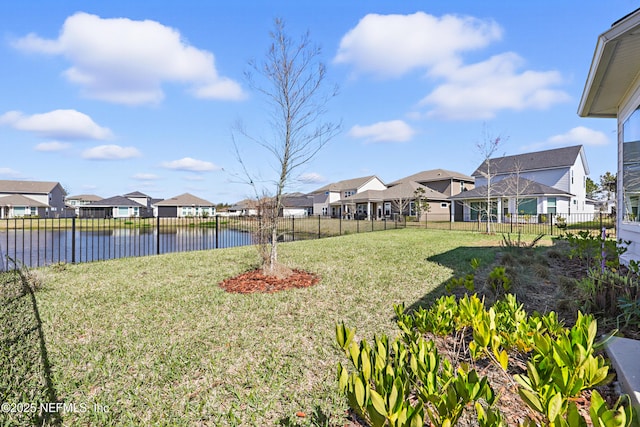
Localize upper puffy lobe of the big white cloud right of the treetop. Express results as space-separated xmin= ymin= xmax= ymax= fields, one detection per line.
xmin=334 ymin=12 xmax=502 ymax=76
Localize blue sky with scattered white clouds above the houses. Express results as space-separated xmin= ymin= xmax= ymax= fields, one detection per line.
xmin=0 ymin=0 xmax=640 ymax=203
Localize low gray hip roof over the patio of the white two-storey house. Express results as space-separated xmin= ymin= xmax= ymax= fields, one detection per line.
xmin=449 ymin=176 xmax=573 ymax=200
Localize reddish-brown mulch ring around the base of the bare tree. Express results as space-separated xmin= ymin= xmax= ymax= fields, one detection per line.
xmin=220 ymin=269 xmax=320 ymax=294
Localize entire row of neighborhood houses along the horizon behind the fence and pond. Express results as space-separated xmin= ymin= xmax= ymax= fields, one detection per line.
xmin=0 ymin=145 xmax=595 ymax=222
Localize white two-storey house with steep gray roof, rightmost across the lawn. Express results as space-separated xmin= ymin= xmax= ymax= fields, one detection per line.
xmin=450 ymin=145 xmax=594 ymax=222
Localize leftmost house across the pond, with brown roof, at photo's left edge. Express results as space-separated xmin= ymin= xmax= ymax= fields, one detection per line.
xmin=0 ymin=180 xmax=67 ymax=218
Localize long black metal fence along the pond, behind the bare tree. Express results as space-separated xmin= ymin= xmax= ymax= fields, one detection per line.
xmin=0 ymin=216 xmax=405 ymax=270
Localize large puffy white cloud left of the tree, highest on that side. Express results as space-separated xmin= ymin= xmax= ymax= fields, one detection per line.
xmin=13 ymin=12 xmax=244 ymax=105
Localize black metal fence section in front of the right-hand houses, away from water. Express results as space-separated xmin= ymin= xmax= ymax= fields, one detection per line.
xmin=407 ymin=212 xmax=616 ymax=237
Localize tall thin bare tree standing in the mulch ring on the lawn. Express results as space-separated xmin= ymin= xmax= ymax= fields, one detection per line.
xmin=234 ymin=19 xmax=340 ymax=275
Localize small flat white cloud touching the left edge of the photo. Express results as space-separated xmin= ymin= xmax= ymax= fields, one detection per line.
xmin=0 ymin=110 xmax=112 ymax=140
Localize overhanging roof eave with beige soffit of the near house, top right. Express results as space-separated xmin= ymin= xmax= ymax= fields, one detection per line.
xmin=578 ymin=9 xmax=640 ymax=118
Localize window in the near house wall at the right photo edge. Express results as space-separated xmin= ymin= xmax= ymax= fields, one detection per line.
xmin=622 ymin=108 xmax=640 ymax=221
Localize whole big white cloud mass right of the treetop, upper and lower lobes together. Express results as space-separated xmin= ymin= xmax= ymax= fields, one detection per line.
xmin=334 ymin=12 xmax=569 ymax=120
